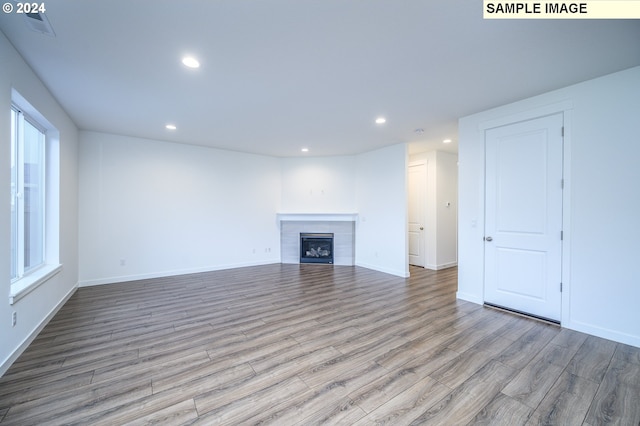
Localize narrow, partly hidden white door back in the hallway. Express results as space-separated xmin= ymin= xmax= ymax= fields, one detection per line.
xmin=407 ymin=164 xmax=427 ymax=267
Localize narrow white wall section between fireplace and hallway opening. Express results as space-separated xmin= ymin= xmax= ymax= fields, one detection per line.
xmin=356 ymin=144 xmax=409 ymax=277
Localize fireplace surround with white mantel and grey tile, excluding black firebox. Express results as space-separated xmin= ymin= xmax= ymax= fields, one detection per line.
xmin=278 ymin=213 xmax=358 ymax=266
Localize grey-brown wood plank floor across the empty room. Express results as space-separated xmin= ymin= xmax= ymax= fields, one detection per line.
xmin=0 ymin=264 xmax=640 ymax=426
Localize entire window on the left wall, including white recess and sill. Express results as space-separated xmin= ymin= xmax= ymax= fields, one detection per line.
xmin=5 ymin=90 xmax=62 ymax=304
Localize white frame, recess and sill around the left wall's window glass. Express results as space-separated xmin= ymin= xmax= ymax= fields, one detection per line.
xmin=9 ymin=90 xmax=62 ymax=304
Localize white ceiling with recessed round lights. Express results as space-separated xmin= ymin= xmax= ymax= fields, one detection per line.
xmin=0 ymin=0 xmax=640 ymax=157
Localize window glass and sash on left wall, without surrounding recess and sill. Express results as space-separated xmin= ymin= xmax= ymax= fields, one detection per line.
xmin=11 ymin=106 xmax=46 ymax=280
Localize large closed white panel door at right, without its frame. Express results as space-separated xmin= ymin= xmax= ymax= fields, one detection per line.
xmin=484 ymin=114 xmax=563 ymax=321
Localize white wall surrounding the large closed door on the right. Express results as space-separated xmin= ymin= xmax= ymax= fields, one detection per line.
xmin=458 ymin=67 xmax=640 ymax=346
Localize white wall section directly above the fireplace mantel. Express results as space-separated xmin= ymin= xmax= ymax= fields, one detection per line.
xmin=281 ymin=156 xmax=356 ymax=213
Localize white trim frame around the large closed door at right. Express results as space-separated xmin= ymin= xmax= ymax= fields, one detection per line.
xmin=478 ymin=101 xmax=573 ymax=324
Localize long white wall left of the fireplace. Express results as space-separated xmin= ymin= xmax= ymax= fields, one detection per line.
xmin=80 ymin=132 xmax=280 ymax=285
